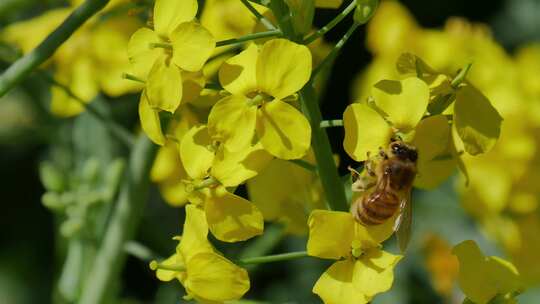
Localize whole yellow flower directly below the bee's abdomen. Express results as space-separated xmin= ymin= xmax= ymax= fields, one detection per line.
xmin=307 ymin=210 xmax=401 ymax=304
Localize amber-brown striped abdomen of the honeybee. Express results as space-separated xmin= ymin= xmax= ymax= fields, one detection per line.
xmin=356 ymin=191 xmax=399 ymax=225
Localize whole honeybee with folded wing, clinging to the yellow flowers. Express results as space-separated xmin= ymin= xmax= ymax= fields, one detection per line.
xmin=351 ymin=140 xmax=418 ymax=252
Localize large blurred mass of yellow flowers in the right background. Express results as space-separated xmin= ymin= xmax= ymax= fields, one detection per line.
xmin=354 ymin=1 xmax=540 ymax=285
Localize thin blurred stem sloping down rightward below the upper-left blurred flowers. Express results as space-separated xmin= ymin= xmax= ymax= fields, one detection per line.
xmin=39 ymin=71 xmax=134 ymax=147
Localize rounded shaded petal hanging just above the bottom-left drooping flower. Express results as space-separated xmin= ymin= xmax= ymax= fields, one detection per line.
xmin=205 ymin=191 xmax=264 ymax=242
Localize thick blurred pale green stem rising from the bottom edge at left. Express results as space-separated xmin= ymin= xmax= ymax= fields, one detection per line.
xmin=78 ymin=134 xmax=156 ymax=304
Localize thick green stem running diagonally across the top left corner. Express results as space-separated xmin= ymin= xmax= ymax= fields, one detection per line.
xmin=0 ymin=0 xmax=109 ymax=97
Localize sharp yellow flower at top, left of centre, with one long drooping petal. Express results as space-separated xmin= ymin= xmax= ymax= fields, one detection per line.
xmin=128 ymin=0 xmax=215 ymax=145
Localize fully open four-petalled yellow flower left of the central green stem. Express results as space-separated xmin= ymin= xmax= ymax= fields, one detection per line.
xmin=208 ymin=39 xmax=311 ymax=159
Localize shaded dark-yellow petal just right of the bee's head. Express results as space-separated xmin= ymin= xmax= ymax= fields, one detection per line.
xmin=413 ymin=115 xmax=457 ymax=189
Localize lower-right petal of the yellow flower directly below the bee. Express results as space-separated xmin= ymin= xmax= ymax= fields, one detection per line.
xmin=353 ymin=248 xmax=401 ymax=298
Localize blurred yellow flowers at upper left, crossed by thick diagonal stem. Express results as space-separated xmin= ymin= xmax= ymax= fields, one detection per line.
xmin=0 ymin=1 xmax=138 ymax=117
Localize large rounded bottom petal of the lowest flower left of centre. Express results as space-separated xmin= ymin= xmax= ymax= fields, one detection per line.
xmin=184 ymin=252 xmax=250 ymax=303
